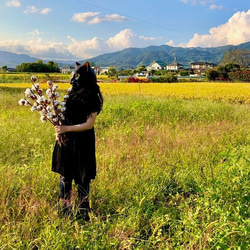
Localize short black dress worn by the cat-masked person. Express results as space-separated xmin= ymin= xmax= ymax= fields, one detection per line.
xmin=52 ymin=88 xmax=100 ymax=182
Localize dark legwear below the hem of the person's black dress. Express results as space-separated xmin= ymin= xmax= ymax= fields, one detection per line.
xmin=60 ymin=176 xmax=90 ymax=206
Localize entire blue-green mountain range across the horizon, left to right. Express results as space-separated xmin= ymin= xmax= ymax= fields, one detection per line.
xmin=0 ymin=42 xmax=250 ymax=69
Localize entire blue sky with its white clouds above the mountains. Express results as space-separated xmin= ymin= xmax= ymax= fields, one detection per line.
xmin=0 ymin=0 xmax=250 ymax=60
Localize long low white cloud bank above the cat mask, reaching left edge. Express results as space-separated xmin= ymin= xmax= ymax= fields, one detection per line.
xmin=0 ymin=29 xmax=162 ymax=60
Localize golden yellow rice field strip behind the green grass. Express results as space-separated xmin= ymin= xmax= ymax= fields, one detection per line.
xmin=0 ymin=82 xmax=250 ymax=104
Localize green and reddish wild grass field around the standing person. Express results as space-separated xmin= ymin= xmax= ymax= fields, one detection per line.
xmin=0 ymin=83 xmax=250 ymax=249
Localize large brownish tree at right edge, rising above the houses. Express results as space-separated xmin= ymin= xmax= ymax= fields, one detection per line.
xmin=221 ymin=49 xmax=250 ymax=69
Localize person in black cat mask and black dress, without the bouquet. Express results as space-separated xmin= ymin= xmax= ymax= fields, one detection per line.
xmin=52 ymin=62 xmax=103 ymax=220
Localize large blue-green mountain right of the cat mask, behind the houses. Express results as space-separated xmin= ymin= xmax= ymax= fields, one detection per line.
xmin=83 ymin=42 xmax=250 ymax=69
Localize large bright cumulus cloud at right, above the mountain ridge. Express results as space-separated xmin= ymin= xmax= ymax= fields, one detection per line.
xmin=187 ymin=10 xmax=250 ymax=47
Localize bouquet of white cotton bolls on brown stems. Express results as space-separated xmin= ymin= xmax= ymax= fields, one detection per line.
xmin=18 ymin=76 xmax=71 ymax=145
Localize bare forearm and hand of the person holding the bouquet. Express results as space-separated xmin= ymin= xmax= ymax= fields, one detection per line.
xmin=55 ymin=113 xmax=97 ymax=136
